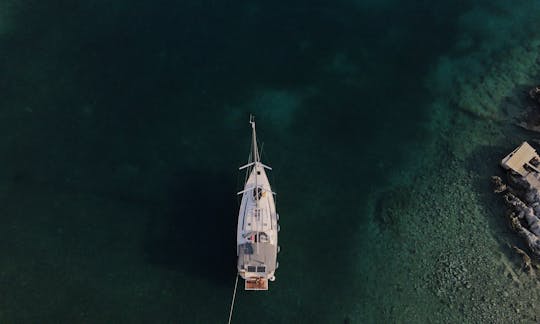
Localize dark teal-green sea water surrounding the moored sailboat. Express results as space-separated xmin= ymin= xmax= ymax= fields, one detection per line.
xmin=0 ymin=0 xmax=540 ymax=323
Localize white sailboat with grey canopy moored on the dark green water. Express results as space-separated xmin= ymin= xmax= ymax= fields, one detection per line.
xmin=236 ymin=116 xmax=279 ymax=290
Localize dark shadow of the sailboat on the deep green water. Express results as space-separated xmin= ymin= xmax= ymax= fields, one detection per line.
xmin=145 ymin=170 xmax=238 ymax=285
